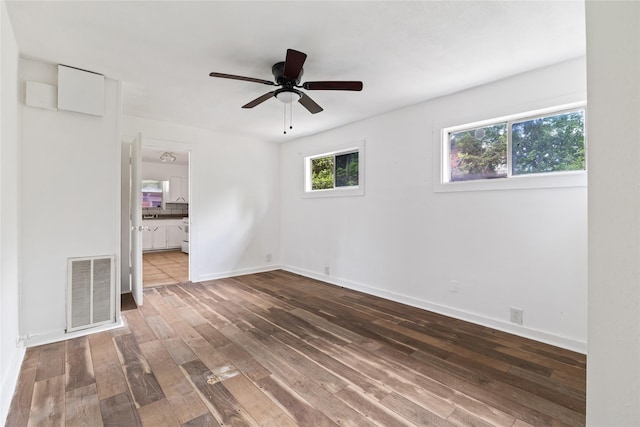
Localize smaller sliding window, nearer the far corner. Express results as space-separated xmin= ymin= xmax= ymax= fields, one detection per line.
xmin=305 ymin=144 xmax=364 ymax=196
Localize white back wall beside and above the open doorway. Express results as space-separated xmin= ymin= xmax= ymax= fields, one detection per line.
xmin=123 ymin=116 xmax=280 ymax=281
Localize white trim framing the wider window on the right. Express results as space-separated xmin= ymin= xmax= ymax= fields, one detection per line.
xmin=433 ymin=101 xmax=588 ymax=193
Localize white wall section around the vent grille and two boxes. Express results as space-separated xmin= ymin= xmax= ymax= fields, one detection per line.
xmin=20 ymin=59 xmax=120 ymax=344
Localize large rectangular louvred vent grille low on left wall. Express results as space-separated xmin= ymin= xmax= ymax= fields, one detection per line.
xmin=67 ymin=256 xmax=115 ymax=332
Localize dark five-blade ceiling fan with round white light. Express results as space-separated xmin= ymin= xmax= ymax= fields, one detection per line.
xmin=209 ymin=49 xmax=362 ymax=114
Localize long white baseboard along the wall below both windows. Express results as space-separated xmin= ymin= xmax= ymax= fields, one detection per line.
xmin=281 ymin=266 xmax=587 ymax=354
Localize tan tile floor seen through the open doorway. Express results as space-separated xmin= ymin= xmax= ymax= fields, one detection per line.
xmin=142 ymin=250 xmax=189 ymax=288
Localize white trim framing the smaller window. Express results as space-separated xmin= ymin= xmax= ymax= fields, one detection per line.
xmin=302 ymin=141 xmax=365 ymax=198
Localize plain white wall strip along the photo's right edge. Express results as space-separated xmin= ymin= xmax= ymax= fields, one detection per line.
xmin=586 ymin=1 xmax=640 ymax=427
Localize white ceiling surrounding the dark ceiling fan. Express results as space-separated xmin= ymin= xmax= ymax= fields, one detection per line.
xmin=6 ymin=1 xmax=586 ymax=142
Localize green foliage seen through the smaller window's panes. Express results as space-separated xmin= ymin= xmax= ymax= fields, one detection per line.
xmin=310 ymin=151 xmax=359 ymax=191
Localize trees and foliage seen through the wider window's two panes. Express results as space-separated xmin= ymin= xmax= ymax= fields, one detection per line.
xmin=445 ymin=109 xmax=586 ymax=182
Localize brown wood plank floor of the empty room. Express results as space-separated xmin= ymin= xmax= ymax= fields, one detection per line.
xmin=7 ymin=271 xmax=586 ymax=427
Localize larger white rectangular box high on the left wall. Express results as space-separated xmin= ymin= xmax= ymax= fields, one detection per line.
xmin=58 ymin=65 xmax=104 ymax=116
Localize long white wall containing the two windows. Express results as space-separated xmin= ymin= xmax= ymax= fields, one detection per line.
xmin=281 ymin=58 xmax=587 ymax=351
